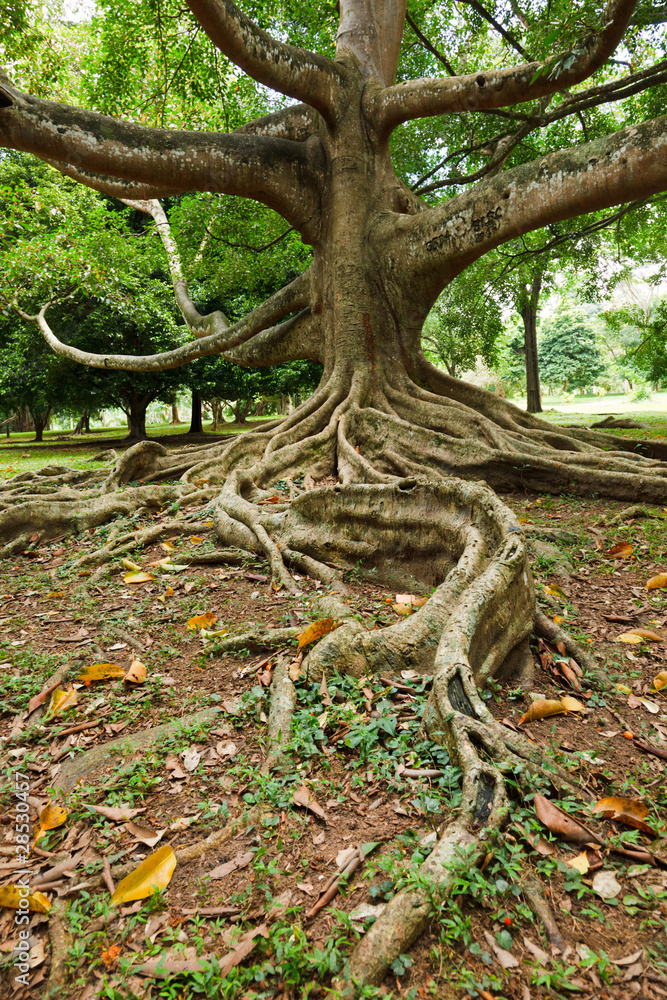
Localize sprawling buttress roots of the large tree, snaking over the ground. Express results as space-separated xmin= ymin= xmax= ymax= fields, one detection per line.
xmin=0 ymin=376 xmax=667 ymax=996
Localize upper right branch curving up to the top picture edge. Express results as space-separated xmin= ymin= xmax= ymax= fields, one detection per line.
xmin=374 ymin=0 xmax=637 ymax=133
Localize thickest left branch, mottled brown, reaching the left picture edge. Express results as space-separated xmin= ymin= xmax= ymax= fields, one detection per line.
xmin=0 ymin=82 xmax=319 ymax=231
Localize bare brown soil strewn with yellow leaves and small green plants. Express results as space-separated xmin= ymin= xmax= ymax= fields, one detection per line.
xmin=0 ymin=466 xmax=667 ymax=1000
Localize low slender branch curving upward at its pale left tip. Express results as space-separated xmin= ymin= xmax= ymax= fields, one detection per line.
xmin=14 ymin=271 xmax=312 ymax=372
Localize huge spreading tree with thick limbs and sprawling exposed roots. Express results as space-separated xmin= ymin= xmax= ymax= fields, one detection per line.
xmin=0 ymin=0 xmax=667 ymax=990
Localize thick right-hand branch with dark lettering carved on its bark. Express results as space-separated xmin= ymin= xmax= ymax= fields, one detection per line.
xmin=388 ymin=117 xmax=667 ymax=301
